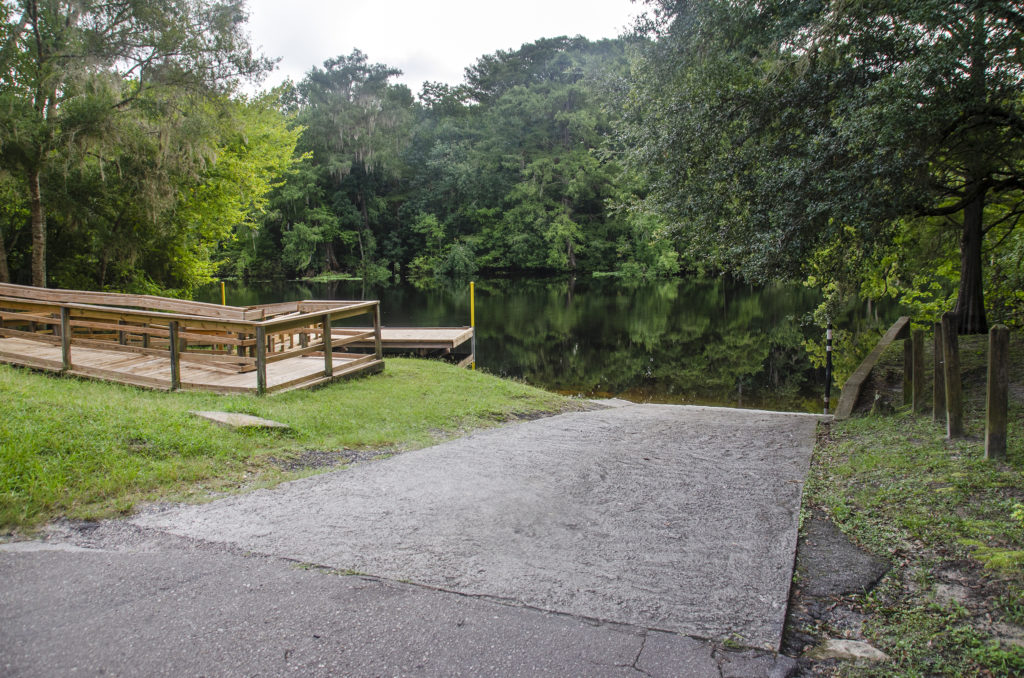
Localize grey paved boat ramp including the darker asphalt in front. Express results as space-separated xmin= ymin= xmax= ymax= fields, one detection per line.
xmin=0 ymin=405 xmax=818 ymax=677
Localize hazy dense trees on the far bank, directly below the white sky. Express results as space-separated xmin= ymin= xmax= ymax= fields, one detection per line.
xmin=218 ymin=38 xmax=678 ymax=280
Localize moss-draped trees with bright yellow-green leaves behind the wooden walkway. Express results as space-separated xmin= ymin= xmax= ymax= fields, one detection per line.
xmin=0 ymin=0 xmax=269 ymax=289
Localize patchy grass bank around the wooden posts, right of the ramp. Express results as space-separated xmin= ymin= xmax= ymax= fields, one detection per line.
xmin=805 ymin=335 xmax=1024 ymax=677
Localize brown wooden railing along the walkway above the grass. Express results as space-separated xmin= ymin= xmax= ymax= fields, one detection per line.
xmin=0 ymin=284 xmax=382 ymax=394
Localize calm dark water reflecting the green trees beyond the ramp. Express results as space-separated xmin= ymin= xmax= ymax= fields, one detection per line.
xmin=197 ymin=278 xmax=888 ymax=412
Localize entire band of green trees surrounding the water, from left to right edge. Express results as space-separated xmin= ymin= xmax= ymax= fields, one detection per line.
xmin=0 ymin=0 xmax=1024 ymax=331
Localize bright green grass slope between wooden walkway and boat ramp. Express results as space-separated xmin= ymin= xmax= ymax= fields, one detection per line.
xmin=0 ymin=358 xmax=573 ymax=533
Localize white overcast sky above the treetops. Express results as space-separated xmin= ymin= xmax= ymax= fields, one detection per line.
xmin=242 ymin=0 xmax=641 ymax=94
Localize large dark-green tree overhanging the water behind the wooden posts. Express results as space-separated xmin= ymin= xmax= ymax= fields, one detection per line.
xmin=623 ymin=0 xmax=1024 ymax=331
